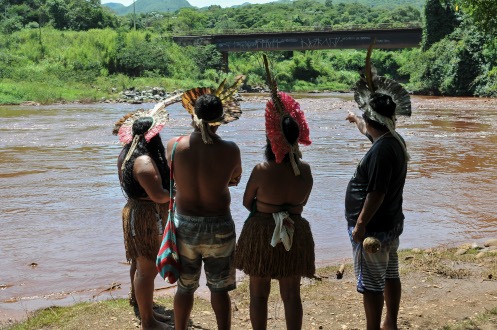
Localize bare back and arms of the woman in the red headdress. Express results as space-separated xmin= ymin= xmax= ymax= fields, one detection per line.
xmin=243 ymin=161 xmax=313 ymax=214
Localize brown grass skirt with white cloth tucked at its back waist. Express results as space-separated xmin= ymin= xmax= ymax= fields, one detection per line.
xmin=235 ymin=212 xmax=316 ymax=279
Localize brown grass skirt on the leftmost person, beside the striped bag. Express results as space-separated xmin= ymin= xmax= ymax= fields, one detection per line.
xmin=122 ymin=199 xmax=169 ymax=261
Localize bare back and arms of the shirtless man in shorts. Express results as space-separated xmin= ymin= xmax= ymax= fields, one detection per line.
xmin=167 ymin=132 xmax=242 ymax=216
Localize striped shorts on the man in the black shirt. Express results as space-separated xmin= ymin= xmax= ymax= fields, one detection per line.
xmin=348 ymin=227 xmax=400 ymax=293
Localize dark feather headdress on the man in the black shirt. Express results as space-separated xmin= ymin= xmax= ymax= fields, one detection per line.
xmin=354 ymin=39 xmax=411 ymax=159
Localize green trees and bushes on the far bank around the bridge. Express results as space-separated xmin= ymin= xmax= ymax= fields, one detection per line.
xmin=0 ymin=0 xmax=497 ymax=104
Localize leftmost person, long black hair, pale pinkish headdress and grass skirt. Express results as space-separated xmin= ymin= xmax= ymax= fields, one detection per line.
xmin=113 ymin=96 xmax=180 ymax=329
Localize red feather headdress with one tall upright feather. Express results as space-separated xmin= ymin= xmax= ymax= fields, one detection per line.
xmin=262 ymin=55 xmax=311 ymax=175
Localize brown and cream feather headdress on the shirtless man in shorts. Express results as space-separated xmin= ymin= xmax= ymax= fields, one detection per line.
xmin=181 ymin=75 xmax=245 ymax=144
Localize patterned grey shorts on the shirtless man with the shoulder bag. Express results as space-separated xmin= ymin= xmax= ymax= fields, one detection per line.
xmin=174 ymin=212 xmax=236 ymax=293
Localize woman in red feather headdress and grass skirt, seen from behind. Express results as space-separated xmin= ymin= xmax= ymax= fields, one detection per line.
xmin=235 ymin=56 xmax=315 ymax=329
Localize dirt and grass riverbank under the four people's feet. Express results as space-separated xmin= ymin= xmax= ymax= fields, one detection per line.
xmin=0 ymin=239 xmax=497 ymax=330
